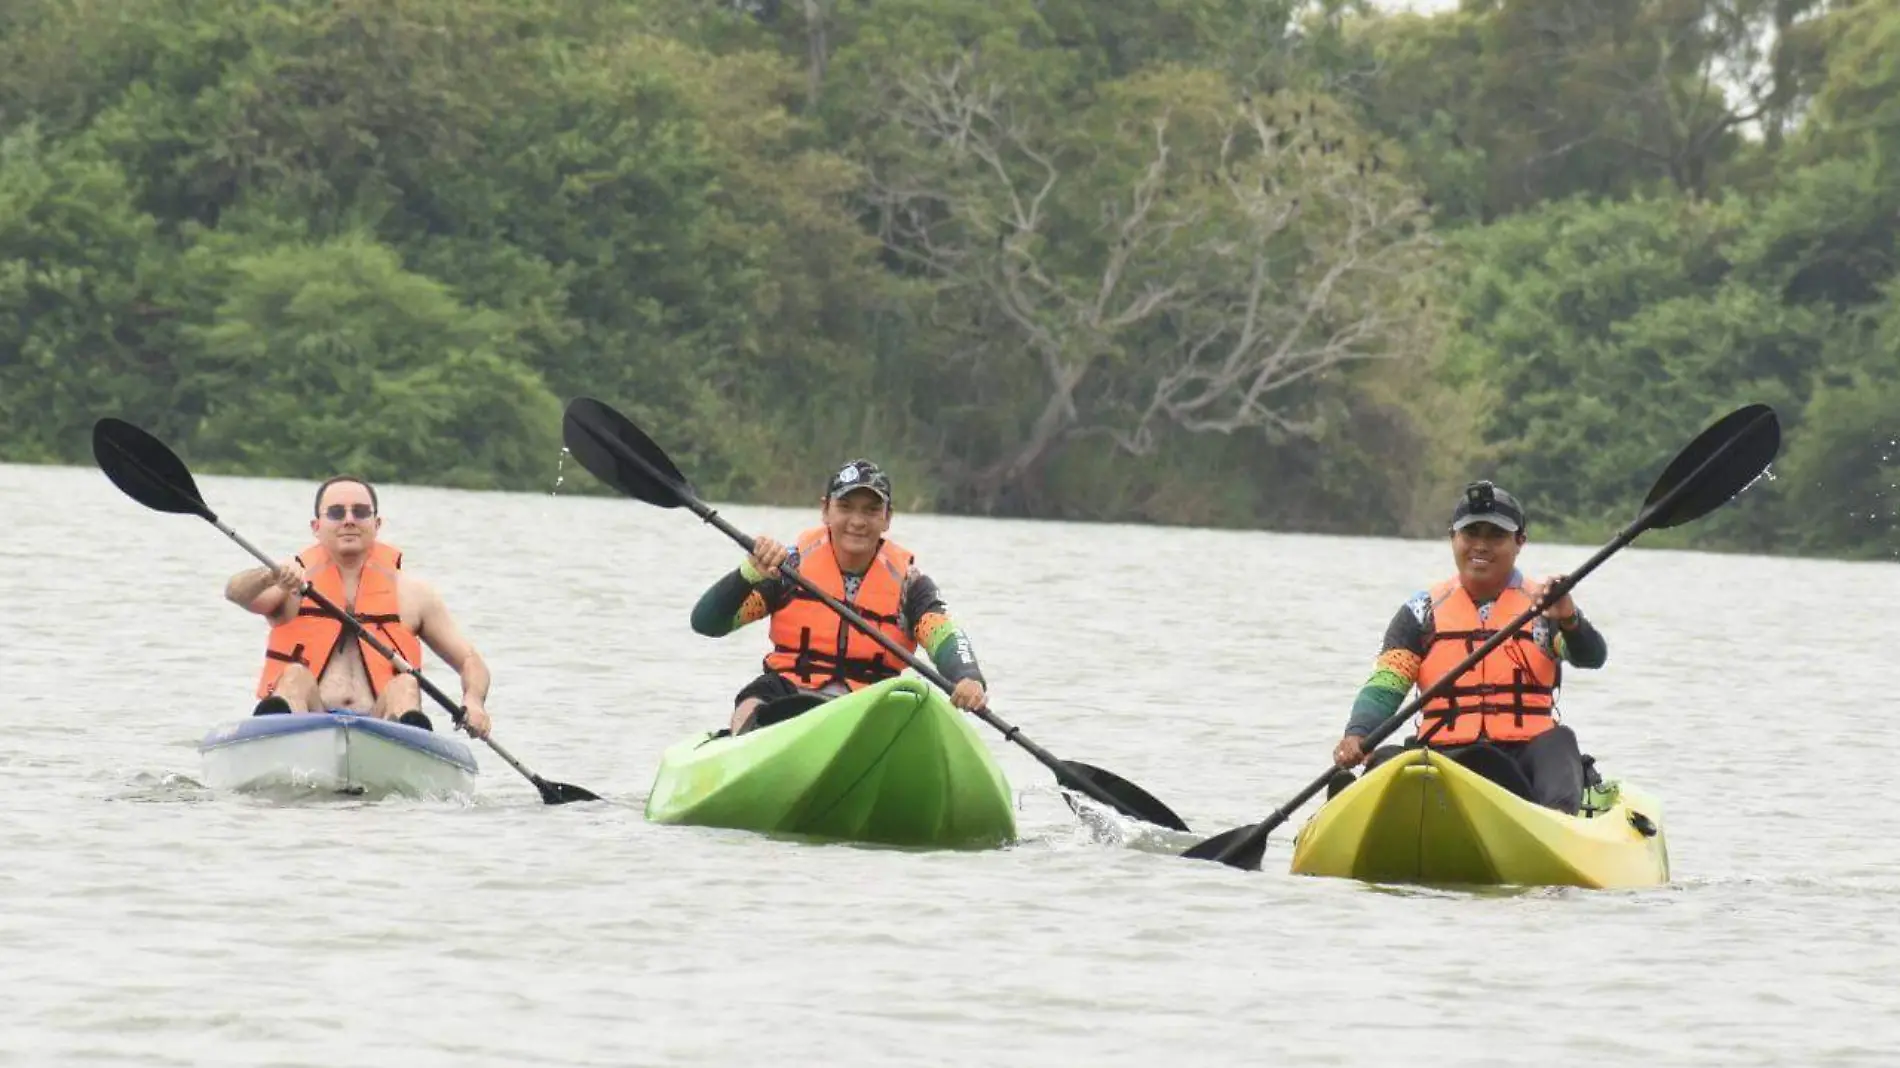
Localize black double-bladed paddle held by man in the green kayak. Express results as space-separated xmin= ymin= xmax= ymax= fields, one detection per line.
xmin=561 ymin=397 xmax=1188 ymax=830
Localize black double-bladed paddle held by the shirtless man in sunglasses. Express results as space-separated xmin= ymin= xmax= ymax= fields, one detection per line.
xmin=93 ymin=418 xmax=600 ymax=804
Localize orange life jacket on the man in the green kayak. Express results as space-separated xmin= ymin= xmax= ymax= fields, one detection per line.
xmin=766 ymin=526 xmax=918 ymax=690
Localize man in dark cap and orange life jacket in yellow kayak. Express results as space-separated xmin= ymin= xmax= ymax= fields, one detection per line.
xmin=1332 ymin=483 xmax=1609 ymax=813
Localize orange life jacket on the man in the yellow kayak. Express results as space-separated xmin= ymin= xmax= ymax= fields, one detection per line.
xmin=1417 ymin=578 xmax=1562 ymax=745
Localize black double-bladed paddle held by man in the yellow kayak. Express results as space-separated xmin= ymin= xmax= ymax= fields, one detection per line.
xmin=1182 ymin=405 xmax=1780 ymax=870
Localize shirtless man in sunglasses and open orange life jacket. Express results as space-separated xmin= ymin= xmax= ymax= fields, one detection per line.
xmin=224 ymin=475 xmax=488 ymax=737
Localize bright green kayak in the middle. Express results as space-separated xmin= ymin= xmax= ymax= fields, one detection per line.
xmin=646 ymin=678 xmax=1017 ymax=849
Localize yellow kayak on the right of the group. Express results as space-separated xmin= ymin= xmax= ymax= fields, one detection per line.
xmin=1292 ymin=749 xmax=1668 ymax=887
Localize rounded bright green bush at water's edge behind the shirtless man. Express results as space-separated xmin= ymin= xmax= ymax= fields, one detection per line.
xmin=184 ymin=236 xmax=561 ymax=488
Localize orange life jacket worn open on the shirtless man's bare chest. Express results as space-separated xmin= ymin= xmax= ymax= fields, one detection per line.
xmin=257 ymin=542 xmax=422 ymax=697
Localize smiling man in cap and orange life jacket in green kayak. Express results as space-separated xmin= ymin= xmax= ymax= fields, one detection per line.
xmin=692 ymin=452 xmax=988 ymax=734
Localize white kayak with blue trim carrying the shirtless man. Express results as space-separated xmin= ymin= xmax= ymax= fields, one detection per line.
xmin=198 ymin=711 xmax=477 ymax=798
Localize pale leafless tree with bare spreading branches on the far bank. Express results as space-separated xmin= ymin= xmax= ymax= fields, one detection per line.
xmin=872 ymin=63 xmax=1436 ymax=501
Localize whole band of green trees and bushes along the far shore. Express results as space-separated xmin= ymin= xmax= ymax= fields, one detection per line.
xmin=0 ymin=0 xmax=1900 ymax=559
